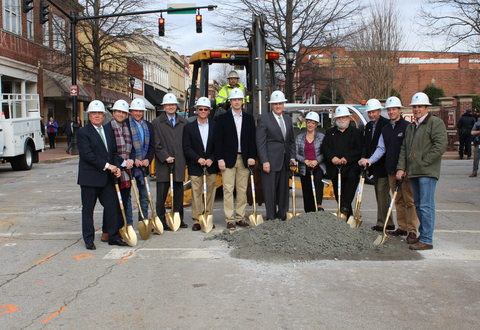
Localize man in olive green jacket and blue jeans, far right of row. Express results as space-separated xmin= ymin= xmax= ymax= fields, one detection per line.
xmin=396 ymin=93 xmax=447 ymax=250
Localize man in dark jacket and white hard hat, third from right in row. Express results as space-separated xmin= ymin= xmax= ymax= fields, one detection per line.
xmin=358 ymin=99 xmax=395 ymax=231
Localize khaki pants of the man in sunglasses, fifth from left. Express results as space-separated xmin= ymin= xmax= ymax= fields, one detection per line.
xmin=190 ymin=173 xmax=217 ymax=223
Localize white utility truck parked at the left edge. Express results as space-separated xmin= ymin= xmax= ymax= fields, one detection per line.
xmin=0 ymin=94 xmax=45 ymax=171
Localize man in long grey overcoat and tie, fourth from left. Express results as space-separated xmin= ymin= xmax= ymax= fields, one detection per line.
xmin=152 ymin=93 xmax=188 ymax=230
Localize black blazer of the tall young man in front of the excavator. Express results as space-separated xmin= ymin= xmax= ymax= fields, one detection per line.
xmin=215 ymin=109 xmax=257 ymax=168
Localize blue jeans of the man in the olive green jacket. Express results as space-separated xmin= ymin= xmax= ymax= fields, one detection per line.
xmin=410 ymin=176 xmax=437 ymax=245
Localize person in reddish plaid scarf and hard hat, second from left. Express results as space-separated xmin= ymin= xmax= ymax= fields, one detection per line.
xmin=100 ymin=100 xmax=135 ymax=242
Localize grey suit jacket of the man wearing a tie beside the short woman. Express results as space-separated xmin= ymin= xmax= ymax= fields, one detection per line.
xmin=257 ymin=112 xmax=296 ymax=171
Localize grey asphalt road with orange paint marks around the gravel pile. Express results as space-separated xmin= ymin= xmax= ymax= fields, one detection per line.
xmin=0 ymin=159 xmax=480 ymax=329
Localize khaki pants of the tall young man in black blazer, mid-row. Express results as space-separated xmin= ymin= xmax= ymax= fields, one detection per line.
xmin=222 ymin=155 xmax=249 ymax=223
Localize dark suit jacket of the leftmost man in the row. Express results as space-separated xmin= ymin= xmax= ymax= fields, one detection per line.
xmin=77 ymin=124 xmax=123 ymax=187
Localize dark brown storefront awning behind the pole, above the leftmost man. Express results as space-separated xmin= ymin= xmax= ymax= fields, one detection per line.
xmin=43 ymin=70 xmax=92 ymax=101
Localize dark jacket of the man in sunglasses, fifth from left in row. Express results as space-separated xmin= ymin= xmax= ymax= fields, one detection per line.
xmin=183 ymin=120 xmax=218 ymax=176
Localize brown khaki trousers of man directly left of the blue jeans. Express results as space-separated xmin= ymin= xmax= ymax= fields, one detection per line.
xmin=388 ymin=173 xmax=419 ymax=235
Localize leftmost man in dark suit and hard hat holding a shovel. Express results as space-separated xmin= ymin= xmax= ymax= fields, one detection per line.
xmin=77 ymin=100 xmax=127 ymax=250
